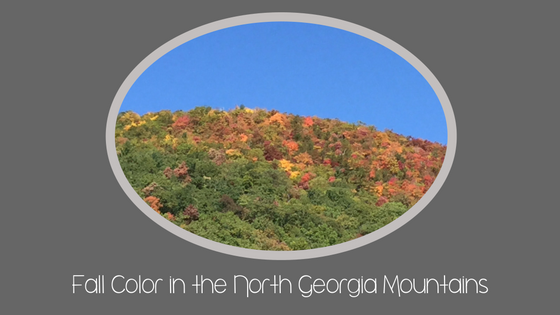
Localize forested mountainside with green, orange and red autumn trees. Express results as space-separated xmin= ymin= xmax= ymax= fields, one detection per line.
xmin=115 ymin=106 xmax=446 ymax=250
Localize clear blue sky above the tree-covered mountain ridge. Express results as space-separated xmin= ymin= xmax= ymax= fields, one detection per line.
xmin=120 ymin=22 xmax=447 ymax=144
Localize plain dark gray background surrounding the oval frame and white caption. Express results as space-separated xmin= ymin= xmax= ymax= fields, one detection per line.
xmin=0 ymin=1 xmax=559 ymax=314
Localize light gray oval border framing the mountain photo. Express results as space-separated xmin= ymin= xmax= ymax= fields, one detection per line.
xmin=106 ymin=13 xmax=457 ymax=260
